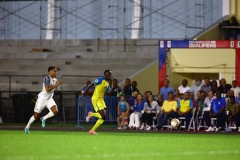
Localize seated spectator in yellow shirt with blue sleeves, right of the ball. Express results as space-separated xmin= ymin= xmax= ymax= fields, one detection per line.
xmin=177 ymin=92 xmax=193 ymax=130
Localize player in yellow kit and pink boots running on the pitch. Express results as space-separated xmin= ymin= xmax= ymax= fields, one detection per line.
xmin=83 ymin=70 xmax=112 ymax=134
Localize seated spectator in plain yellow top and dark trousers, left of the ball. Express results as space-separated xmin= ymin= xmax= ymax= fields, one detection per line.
xmin=157 ymin=92 xmax=178 ymax=129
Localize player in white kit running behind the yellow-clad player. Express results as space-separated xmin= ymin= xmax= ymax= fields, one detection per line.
xmin=24 ymin=66 xmax=62 ymax=134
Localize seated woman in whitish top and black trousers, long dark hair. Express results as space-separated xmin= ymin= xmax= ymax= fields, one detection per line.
xmin=140 ymin=94 xmax=160 ymax=130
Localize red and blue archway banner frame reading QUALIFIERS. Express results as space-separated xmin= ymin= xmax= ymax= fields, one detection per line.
xmin=158 ymin=40 xmax=240 ymax=88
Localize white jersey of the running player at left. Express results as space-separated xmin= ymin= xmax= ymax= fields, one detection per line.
xmin=38 ymin=75 xmax=57 ymax=99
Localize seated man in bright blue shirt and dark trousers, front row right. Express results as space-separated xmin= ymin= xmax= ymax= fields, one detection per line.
xmin=203 ymin=91 xmax=226 ymax=132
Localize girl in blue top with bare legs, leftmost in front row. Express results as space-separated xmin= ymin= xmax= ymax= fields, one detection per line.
xmin=117 ymin=94 xmax=130 ymax=129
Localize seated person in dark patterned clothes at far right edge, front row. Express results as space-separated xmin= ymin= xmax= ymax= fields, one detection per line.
xmin=226 ymin=96 xmax=240 ymax=132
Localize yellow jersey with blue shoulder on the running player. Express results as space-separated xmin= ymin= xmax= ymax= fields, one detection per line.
xmin=92 ymin=77 xmax=111 ymax=98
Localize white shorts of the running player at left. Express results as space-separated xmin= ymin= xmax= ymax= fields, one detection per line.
xmin=34 ymin=97 xmax=57 ymax=113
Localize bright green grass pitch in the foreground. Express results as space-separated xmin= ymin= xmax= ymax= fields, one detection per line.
xmin=0 ymin=130 xmax=240 ymax=160
